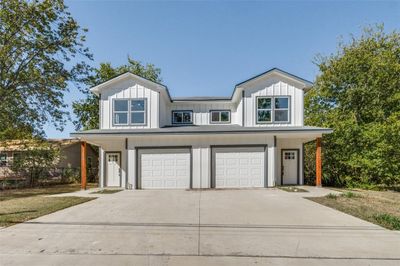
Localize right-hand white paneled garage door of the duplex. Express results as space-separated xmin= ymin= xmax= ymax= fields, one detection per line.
xmin=213 ymin=147 xmax=266 ymax=188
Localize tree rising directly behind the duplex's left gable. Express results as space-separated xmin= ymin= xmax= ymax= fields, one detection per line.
xmin=72 ymin=57 xmax=161 ymax=130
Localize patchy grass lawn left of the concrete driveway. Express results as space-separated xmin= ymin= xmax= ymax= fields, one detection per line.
xmin=0 ymin=185 xmax=94 ymax=227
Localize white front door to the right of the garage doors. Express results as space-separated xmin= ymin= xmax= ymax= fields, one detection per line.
xmin=282 ymin=150 xmax=299 ymax=185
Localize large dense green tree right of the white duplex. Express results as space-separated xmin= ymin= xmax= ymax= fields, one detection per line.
xmin=305 ymin=26 xmax=400 ymax=186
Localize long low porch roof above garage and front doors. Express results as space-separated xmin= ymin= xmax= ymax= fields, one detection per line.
xmin=71 ymin=125 xmax=333 ymax=137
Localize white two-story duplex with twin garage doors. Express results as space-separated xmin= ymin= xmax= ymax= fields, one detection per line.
xmin=71 ymin=68 xmax=332 ymax=189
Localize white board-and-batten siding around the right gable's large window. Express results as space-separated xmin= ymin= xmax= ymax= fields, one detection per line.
xmin=244 ymin=79 xmax=304 ymax=127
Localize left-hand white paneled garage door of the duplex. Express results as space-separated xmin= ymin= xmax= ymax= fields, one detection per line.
xmin=138 ymin=149 xmax=191 ymax=189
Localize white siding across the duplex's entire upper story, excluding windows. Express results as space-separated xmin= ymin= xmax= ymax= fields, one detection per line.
xmin=100 ymin=72 xmax=304 ymax=129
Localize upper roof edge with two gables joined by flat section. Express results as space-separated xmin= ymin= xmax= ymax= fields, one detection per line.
xmin=90 ymin=67 xmax=313 ymax=102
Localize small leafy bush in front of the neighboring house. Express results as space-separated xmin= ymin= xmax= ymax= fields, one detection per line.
xmin=11 ymin=140 xmax=60 ymax=187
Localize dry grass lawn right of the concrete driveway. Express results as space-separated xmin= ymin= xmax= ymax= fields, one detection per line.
xmin=308 ymin=190 xmax=400 ymax=230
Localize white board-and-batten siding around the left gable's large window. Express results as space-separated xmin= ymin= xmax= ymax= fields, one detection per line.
xmin=100 ymin=83 xmax=162 ymax=129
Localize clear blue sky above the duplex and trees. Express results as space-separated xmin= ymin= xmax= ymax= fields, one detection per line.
xmin=45 ymin=1 xmax=400 ymax=138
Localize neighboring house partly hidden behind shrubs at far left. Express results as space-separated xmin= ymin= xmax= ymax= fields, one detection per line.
xmin=0 ymin=139 xmax=98 ymax=178
